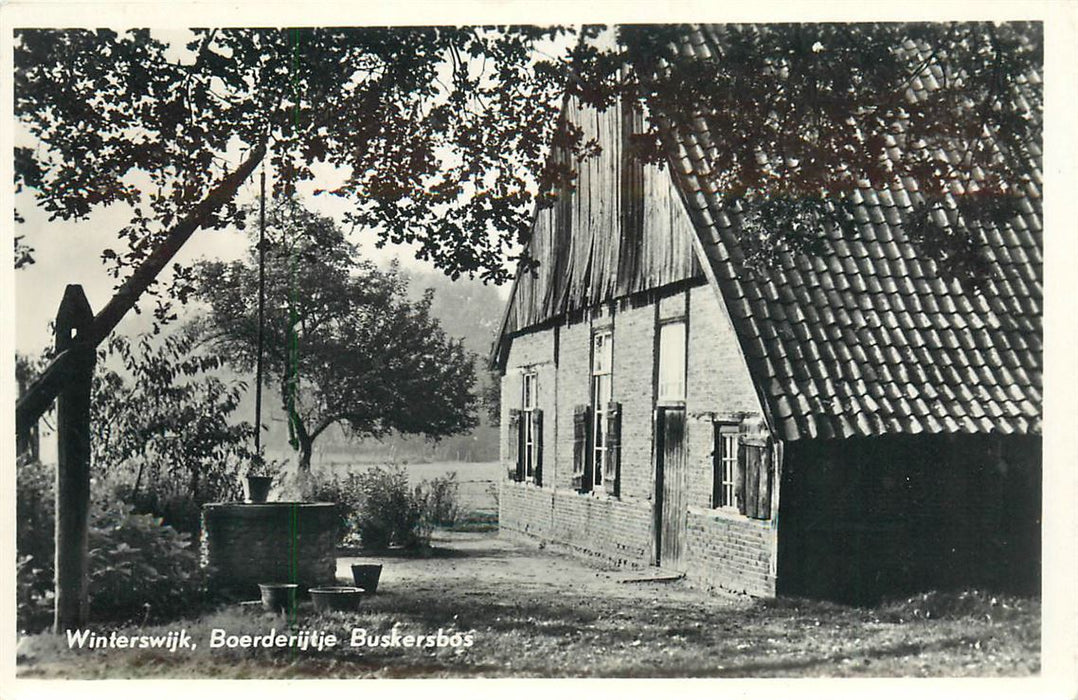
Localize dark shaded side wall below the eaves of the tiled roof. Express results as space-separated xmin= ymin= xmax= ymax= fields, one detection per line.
xmin=777 ymin=435 xmax=1041 ymax=604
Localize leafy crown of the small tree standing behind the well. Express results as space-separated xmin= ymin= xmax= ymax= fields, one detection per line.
xmin=197 ymin=201 xmax=476 ymax=470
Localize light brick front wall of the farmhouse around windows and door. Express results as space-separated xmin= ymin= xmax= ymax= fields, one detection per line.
xmin=499 ymin=286 xmax=775 ymax=595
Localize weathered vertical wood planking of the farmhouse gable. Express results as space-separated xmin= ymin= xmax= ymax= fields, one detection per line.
xmin=506 ymin=101 xmax=700 ymax=333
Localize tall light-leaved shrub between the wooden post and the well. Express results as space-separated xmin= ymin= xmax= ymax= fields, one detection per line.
xmin=91 ymin=327 xmax=254 ymax=534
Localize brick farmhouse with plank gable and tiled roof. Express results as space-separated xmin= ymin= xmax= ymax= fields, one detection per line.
xmin=492 ymin=30 xmax=1042 ymax=601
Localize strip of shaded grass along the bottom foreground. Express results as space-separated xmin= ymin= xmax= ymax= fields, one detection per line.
xmin=16 ymin=593 xmax=1039 ymax=677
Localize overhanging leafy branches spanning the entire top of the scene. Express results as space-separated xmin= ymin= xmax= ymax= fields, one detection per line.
xmin=15 ymin=23 xmax=1042 ymax=282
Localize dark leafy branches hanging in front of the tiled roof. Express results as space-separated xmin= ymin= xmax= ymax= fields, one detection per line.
xmin=607 ymin=23 xmax=1042 ymax=288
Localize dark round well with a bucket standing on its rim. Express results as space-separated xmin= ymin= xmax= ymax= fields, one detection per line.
xmin=202 ymin=502 xmax=337 ymax=598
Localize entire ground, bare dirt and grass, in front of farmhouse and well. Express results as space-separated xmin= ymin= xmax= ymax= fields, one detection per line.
xmin=18 ymin=533 xmax=1040 ymax=678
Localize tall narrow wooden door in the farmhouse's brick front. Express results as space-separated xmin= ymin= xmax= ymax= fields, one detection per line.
xmin=655 ymin=409 xmax=688 ymax=571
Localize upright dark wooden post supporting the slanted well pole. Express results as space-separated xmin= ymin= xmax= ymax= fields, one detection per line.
xmin=54 ymin=285 xmax=95 ymax=632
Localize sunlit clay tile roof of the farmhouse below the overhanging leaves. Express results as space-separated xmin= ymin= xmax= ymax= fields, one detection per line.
xmin=669 ymin=30 xmax=1042 ymax=440
